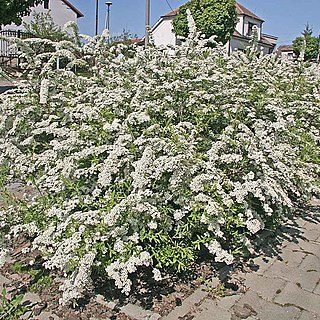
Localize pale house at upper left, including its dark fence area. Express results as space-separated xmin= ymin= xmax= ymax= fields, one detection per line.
xmin=0 ymin=0 xmax=84 ymax=62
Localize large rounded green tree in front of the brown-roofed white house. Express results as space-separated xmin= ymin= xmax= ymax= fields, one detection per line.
xmin=173 ymin=0 xmax=238 ymax=43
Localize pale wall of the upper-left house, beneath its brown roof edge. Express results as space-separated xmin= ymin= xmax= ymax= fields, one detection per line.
xmin=3 ymin=0 xmax=77 ymax=30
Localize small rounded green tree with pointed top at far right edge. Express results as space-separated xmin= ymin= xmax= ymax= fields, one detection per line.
xmin=292 ymin=23 xmax=320 ymax=61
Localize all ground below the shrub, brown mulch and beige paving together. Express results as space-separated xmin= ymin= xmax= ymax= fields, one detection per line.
xmin=0 ymin=184 xmax=320 ymax=320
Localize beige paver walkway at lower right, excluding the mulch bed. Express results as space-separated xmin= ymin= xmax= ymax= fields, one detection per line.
xmin=163 ymin=202 xmax=320 ymax=320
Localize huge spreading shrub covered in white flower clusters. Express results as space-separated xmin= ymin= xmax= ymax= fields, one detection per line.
xmin=0 ymin=18 xmax=320 ymax=303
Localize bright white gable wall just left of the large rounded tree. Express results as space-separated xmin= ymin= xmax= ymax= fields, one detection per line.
xmin=151 ymin=17 xmax=176 ymax=46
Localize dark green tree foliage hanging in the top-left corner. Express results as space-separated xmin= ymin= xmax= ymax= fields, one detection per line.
xmin=0 ymin=0 xmax=43 ymax=28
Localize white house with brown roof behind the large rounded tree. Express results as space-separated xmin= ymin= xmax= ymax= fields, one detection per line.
xmin=151 ymin=3 xmax=278 ymax=54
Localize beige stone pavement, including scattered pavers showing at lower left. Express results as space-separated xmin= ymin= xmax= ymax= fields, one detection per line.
xmin=0 ymin=196 xmax=320 ymax=320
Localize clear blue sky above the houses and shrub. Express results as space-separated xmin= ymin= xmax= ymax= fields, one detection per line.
xmin=74 ymin=0 xmax=320 ymax=45
